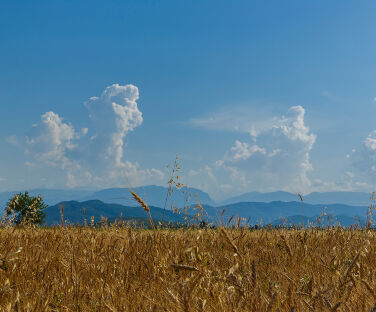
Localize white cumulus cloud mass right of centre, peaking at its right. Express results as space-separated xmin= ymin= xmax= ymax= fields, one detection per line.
xmin=219 ymin=106 xmax=316 ymax=192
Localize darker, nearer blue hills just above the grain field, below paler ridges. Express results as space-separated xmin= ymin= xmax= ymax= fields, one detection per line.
xmin=45 ymin=200 xmax=366 ymax=226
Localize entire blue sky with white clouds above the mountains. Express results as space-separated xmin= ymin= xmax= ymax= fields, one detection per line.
xmin=0 ymin=0 xmax=376 ymax=199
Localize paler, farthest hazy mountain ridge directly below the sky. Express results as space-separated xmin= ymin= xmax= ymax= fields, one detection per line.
xmin=0 ymin=185 xmax=371 ymax=208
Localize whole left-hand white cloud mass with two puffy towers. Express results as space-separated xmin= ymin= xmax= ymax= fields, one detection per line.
xmin=27 ymin=84 xmax=163 ymax=187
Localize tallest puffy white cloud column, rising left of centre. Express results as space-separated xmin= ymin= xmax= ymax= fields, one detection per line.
xmin=85 ymin=84 xmax=143 ymax=166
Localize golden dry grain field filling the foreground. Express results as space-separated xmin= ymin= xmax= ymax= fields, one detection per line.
xmin=0 ymin=227 xmax=376 ymax=311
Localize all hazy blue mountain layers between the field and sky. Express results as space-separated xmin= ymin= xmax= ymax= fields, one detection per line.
xmin=0 ymin=185 xmax=371 ymax=224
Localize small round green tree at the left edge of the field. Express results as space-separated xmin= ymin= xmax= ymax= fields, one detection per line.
xmin=5 ymin=192 xmax=48 ymax=225
